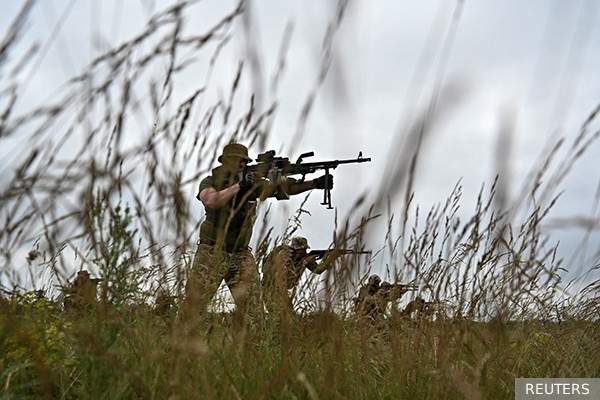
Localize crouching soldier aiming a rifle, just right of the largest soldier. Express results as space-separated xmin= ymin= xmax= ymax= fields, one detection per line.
xmin=262 ymin=236 xmax=338 ymax=317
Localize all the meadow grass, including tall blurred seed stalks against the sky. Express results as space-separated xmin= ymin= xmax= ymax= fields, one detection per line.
xmin=0 ymin=1 xmax=600 ymax=399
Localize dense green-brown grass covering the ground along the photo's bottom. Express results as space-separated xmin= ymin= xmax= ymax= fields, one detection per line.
xmin=0 ymin=295 xmax=600 ymax=399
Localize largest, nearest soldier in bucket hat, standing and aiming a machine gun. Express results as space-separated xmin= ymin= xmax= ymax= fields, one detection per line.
xmin=182 ymin=143 xmax=333 ymax=332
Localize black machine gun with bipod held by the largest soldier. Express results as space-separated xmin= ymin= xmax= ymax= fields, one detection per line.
xmin=246 ymin=150 xmax=371 ymax=209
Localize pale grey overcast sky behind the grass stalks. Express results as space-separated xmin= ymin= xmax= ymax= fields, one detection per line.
xmin=0 ymin=0 xmax=600 ymax=296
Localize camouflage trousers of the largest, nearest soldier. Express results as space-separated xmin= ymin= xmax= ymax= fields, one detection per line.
xmin=182 ymin=244 xmax=263 ymax=332
